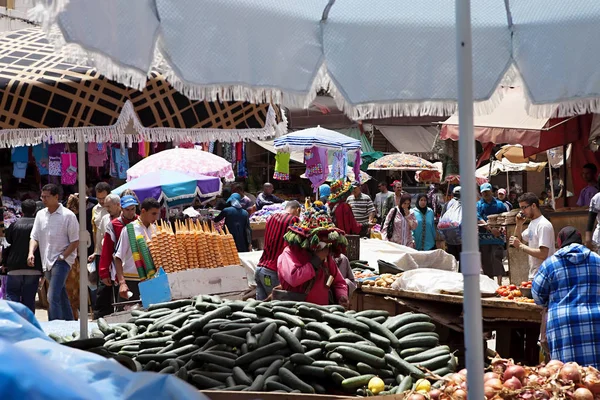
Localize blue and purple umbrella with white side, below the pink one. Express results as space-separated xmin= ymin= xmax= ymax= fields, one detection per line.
xmin=112 ymin=170 xmax=221 ymax=206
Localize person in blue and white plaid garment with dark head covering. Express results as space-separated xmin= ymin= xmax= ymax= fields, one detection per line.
xmin=531 ymin=226 xmax=600 ymax=368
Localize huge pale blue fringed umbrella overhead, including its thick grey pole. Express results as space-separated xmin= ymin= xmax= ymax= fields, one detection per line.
xmin=38 ymin=0 xmax=600 ymax=398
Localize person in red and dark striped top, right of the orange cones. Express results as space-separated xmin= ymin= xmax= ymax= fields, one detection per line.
xmin=254 ymin=200 xmax=301 ymax=300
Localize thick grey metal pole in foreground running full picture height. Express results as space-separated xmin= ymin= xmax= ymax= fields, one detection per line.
xmin=455 ymin=0 xmax=485 ymax=399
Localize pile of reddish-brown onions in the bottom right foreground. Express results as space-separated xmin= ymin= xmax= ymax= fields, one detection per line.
xmin=407 ymin=358 xmax=600 ymax=400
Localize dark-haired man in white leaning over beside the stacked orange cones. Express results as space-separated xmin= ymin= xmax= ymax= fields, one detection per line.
xmin=115 ymin=197 xmax=160 ymax=300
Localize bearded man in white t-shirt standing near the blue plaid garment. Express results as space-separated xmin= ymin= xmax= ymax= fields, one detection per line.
xmin=510 ymin=192 xmax=555 ymax=280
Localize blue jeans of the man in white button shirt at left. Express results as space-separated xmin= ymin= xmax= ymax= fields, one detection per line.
xmin=46 ymin=260 xmax=73 ymax=321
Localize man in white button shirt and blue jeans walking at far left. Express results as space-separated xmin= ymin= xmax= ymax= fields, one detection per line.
xmin=27 ymin=184 xmax=79 ymax=321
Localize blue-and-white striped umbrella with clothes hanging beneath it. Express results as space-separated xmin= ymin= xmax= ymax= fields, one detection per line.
xmin=273 ymin=126 xmax=361 ymax=151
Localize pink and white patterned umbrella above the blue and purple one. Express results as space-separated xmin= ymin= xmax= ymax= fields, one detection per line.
xmin=127 ymin=148 xmax=235 ymax=182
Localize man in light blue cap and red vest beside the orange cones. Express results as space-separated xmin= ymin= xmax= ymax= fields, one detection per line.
xmin=94 ymin=195 xmax=138 ymax=319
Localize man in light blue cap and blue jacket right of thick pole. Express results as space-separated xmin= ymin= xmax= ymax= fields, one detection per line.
xmin=477 ymin=183 xmax=508 ymax=279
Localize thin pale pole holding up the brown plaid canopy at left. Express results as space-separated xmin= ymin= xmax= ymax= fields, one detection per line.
xmin=77 ymin=132 xmax=88 ymax=339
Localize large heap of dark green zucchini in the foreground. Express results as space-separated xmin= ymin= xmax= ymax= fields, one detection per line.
xmin=56 ymin=295 xmax=457 ymax=396
